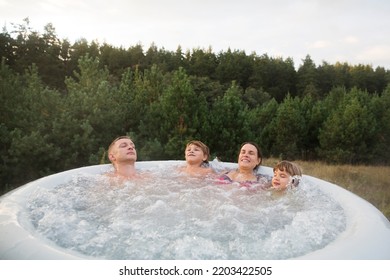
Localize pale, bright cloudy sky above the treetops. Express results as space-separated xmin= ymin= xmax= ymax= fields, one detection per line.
xmin=0 ymin=0 xmax=390 ymax=70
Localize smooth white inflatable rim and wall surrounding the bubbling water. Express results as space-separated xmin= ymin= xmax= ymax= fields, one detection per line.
xmin=0 ymin=161 xmax=390 ymax=260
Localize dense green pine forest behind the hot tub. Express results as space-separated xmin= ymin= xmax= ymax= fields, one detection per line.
xmin=0 ymin=19 xmax=390 ymax=214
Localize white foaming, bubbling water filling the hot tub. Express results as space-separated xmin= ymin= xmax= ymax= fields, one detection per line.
xmin=26 ymin=163 xmax=346 ymax=260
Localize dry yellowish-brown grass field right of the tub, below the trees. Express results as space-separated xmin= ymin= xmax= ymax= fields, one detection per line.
xmin=262 ymin=158 xmax=390 ymax=220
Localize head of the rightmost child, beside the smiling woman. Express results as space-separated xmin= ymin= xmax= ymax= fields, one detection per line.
xmin=272 ymin=160 xmax=302 ymax=189
